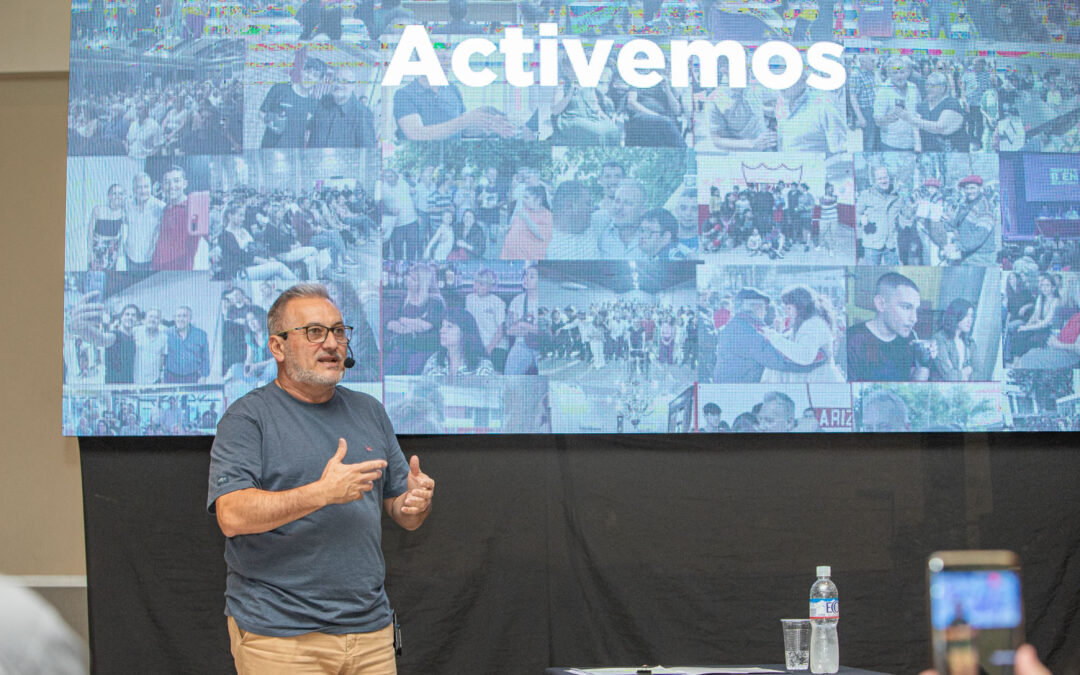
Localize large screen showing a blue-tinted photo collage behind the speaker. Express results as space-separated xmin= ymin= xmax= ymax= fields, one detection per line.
xmin=63 ymin=0 xmax=1080 ymax=436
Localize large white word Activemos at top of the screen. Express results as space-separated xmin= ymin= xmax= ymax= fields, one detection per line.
xmin=382 ymin=24 xmax=848 ymax=91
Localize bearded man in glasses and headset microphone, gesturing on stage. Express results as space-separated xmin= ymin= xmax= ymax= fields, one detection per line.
xmin=207 ymin=283 xmax=435 ymax=675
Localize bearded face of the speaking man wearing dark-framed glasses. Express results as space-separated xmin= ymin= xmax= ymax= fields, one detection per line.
xmin=271 ymin=298 xmax=348 ymax=387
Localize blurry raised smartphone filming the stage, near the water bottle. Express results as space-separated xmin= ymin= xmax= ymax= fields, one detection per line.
xmin=927 ymin=551 xmax=1024 ymax=675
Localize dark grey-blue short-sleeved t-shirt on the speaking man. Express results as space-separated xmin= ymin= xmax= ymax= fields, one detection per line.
xmin=206 ymin=382 xmax=408 ymax=637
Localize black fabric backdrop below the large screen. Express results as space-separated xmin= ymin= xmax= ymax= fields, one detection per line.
xmin=80 ymin=434 xmax=1080 ymax=675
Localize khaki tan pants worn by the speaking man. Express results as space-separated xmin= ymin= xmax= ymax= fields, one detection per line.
xmin=229 ymin=617 xmax=397 ymax=675
